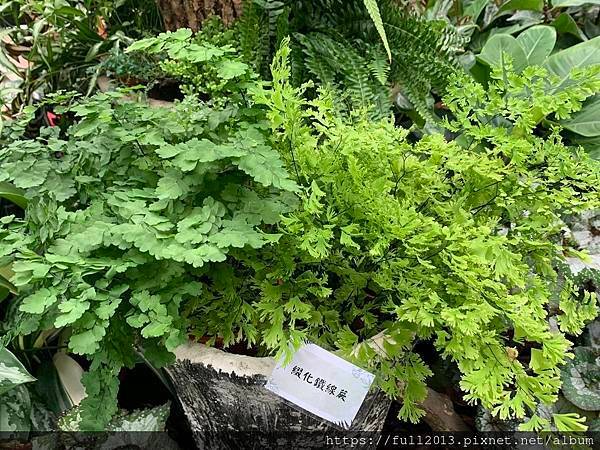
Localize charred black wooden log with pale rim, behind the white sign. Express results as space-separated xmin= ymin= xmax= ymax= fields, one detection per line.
xmin=168 ymin=343 xmax=391 ymax=449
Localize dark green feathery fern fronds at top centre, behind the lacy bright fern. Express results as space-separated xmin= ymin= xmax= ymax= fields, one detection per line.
xmin=245 ymin=0 xmax=465 ymax=119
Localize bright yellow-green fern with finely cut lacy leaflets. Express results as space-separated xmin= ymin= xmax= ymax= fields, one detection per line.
xmin=254 ymin=40 xmax=600 ymax=430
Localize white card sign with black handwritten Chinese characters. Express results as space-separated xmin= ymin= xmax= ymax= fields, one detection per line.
xmin=265 ymin=344 xmax=375 ymax=429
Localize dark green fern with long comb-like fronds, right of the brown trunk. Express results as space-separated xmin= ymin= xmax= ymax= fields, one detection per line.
xmin=278 ymin=0 xmax=466 ymax=118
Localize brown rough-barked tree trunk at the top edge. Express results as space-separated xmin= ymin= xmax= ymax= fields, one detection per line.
xmin=156 ymin=0 xmax=243 ymax=31
